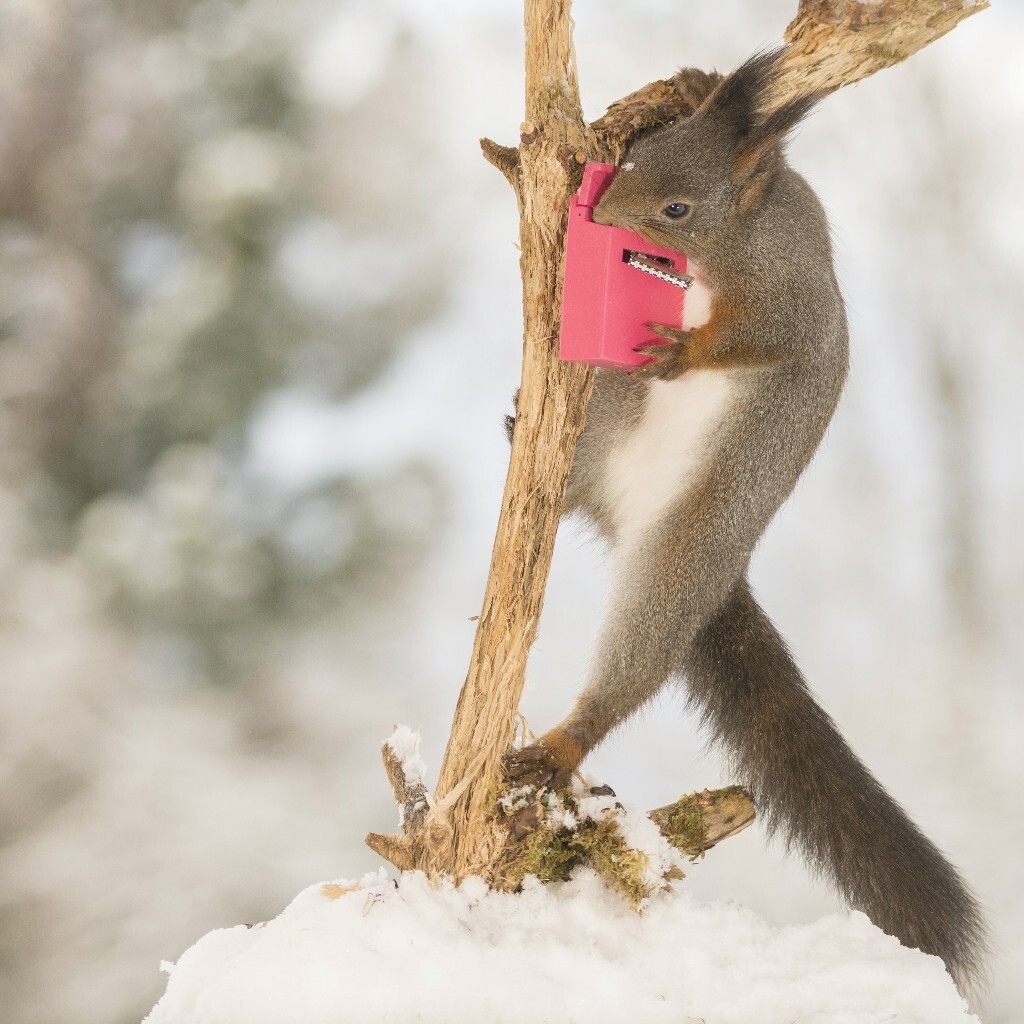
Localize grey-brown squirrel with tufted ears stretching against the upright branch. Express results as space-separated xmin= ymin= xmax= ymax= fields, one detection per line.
xmin=505 ymin=50 xmax=986 ymax=991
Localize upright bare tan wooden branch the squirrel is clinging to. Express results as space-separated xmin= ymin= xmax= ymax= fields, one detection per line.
xmin=425 ymin=0 xmax=593 ymax=879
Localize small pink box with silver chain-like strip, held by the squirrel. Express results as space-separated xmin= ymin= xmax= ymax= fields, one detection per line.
xmin=558 ymin=164 xmax=690 ymax=370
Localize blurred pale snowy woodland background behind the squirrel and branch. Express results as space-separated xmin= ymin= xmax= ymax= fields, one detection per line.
xmin=0 ymin=0 xmax=1024 ymax=1024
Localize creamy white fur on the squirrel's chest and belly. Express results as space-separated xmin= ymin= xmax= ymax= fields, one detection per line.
xmin=605 ymin=267 xmax=734 ymax=548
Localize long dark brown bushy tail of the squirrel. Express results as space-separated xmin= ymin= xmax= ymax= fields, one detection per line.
xmin=685 ymin=580 xmax=986 ymax=992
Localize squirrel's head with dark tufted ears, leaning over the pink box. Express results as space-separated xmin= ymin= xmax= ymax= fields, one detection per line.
xmin=594 ymin=50 xmax=819 ymax=262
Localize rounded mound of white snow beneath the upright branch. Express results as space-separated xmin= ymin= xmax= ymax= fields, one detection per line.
xmin=144 ymin=869 xmax=977 ymax=1024
